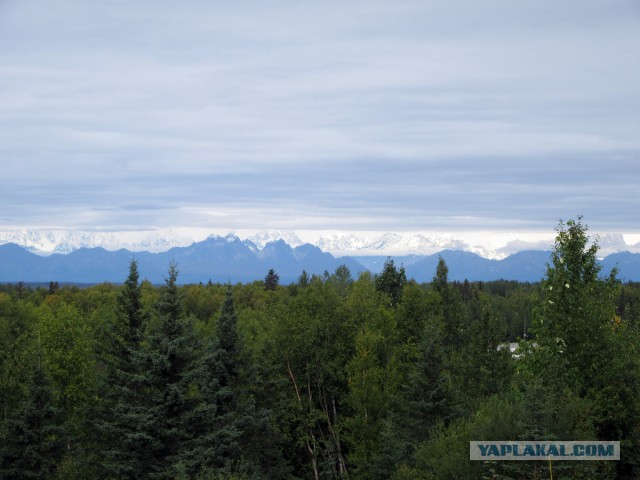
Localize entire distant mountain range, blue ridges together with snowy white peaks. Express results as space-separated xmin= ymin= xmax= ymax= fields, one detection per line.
xmin=0 ymin=232 xmax=640 ymax=284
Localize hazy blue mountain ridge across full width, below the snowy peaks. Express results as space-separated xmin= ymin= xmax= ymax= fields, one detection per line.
xmin=0 ymin=235 xmax=640 ymax=284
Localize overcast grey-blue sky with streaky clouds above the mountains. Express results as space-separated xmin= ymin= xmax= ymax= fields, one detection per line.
xmin=0 ymin=0 xmax=640 ymax=240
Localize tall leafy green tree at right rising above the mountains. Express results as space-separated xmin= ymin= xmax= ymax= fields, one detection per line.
xmin=532 ymin=220 xmax=616 ymax=393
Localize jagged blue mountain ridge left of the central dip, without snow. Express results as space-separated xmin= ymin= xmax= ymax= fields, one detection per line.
xmin=0 ymin=236 xmax=366 ymax=283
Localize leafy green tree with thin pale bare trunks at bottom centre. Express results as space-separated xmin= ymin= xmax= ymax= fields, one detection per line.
xmin=268 ymin=278 xmax=353 ymax=477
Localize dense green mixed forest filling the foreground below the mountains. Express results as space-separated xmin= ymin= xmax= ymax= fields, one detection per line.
xmin=0 ymin=219 xmax=640 ymax=480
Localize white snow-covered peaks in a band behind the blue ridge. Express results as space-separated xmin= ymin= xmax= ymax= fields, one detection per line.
xmin=0 ymin=228 xmax=640 ymax=259
